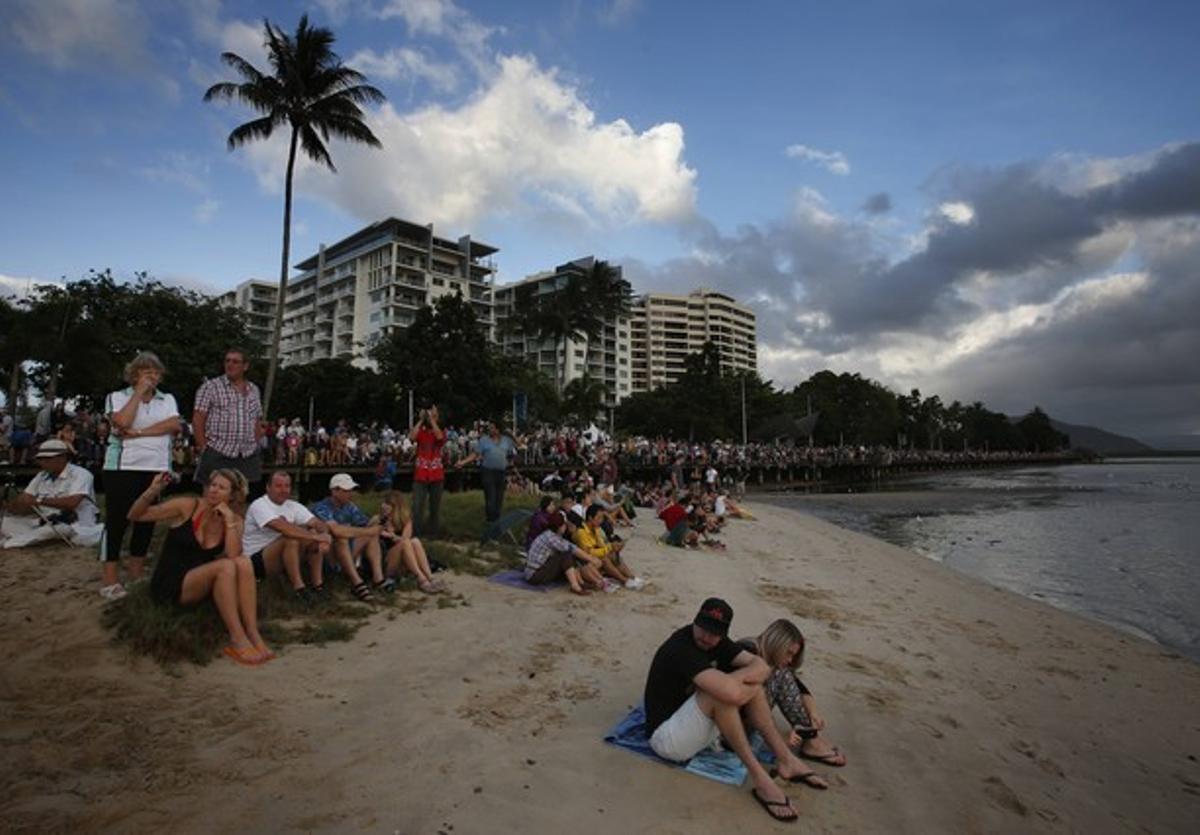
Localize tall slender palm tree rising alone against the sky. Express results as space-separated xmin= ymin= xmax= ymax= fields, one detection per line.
xmin=204 ymin=14 xmax=384 ymax=415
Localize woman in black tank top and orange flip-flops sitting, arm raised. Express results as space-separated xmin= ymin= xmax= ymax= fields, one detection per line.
xmin=130 ymin=469 xmax=275 ymax=666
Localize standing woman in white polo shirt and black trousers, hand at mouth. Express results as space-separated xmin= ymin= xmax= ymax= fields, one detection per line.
xmin=100 ymin=352 xmax=180 ymax=600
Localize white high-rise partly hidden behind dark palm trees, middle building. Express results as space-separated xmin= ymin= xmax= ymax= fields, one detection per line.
xmin=494 ymin=257 xmax=632 ymax=407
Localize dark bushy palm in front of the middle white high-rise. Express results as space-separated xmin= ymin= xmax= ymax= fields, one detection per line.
xmin=508 ymin=258 xmax=630 ymax=392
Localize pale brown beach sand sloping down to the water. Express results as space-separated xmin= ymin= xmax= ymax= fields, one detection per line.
xmin=0 ymin=505 xmax=1200 ymax=835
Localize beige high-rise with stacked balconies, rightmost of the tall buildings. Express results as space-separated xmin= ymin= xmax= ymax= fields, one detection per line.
xmin=630 ymin=288 xmax=758 ymax=392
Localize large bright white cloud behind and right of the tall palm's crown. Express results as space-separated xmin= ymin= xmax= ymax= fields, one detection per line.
xmin=235 ymin=56 xmax=696 ymax=227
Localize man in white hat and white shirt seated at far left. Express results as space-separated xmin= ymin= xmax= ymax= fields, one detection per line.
xmin=0 ymin=438 xmax=103 ymax=548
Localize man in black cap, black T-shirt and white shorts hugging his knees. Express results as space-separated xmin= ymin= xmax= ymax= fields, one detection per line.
xmin=644 ymin=597 xmax=826 ymax=821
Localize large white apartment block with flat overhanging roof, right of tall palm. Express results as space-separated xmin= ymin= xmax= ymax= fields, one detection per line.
xmin=280 ymin=217 xmax=499 ymax=366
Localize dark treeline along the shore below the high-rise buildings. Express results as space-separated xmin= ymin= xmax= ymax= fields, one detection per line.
xmin=0 ymin=271 xmax=1069 ymax=451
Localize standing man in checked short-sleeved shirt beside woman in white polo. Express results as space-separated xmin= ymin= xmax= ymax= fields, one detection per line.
xmin=192 ymin=348 xmax=263 ymax=495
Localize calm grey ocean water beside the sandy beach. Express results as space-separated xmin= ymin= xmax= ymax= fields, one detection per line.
xmin=768 ymin=458 xmax=1200 ymax=661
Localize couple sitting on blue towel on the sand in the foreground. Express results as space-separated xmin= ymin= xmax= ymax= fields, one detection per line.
xmin=644 ymin=597 xmax=846 ymax=822
